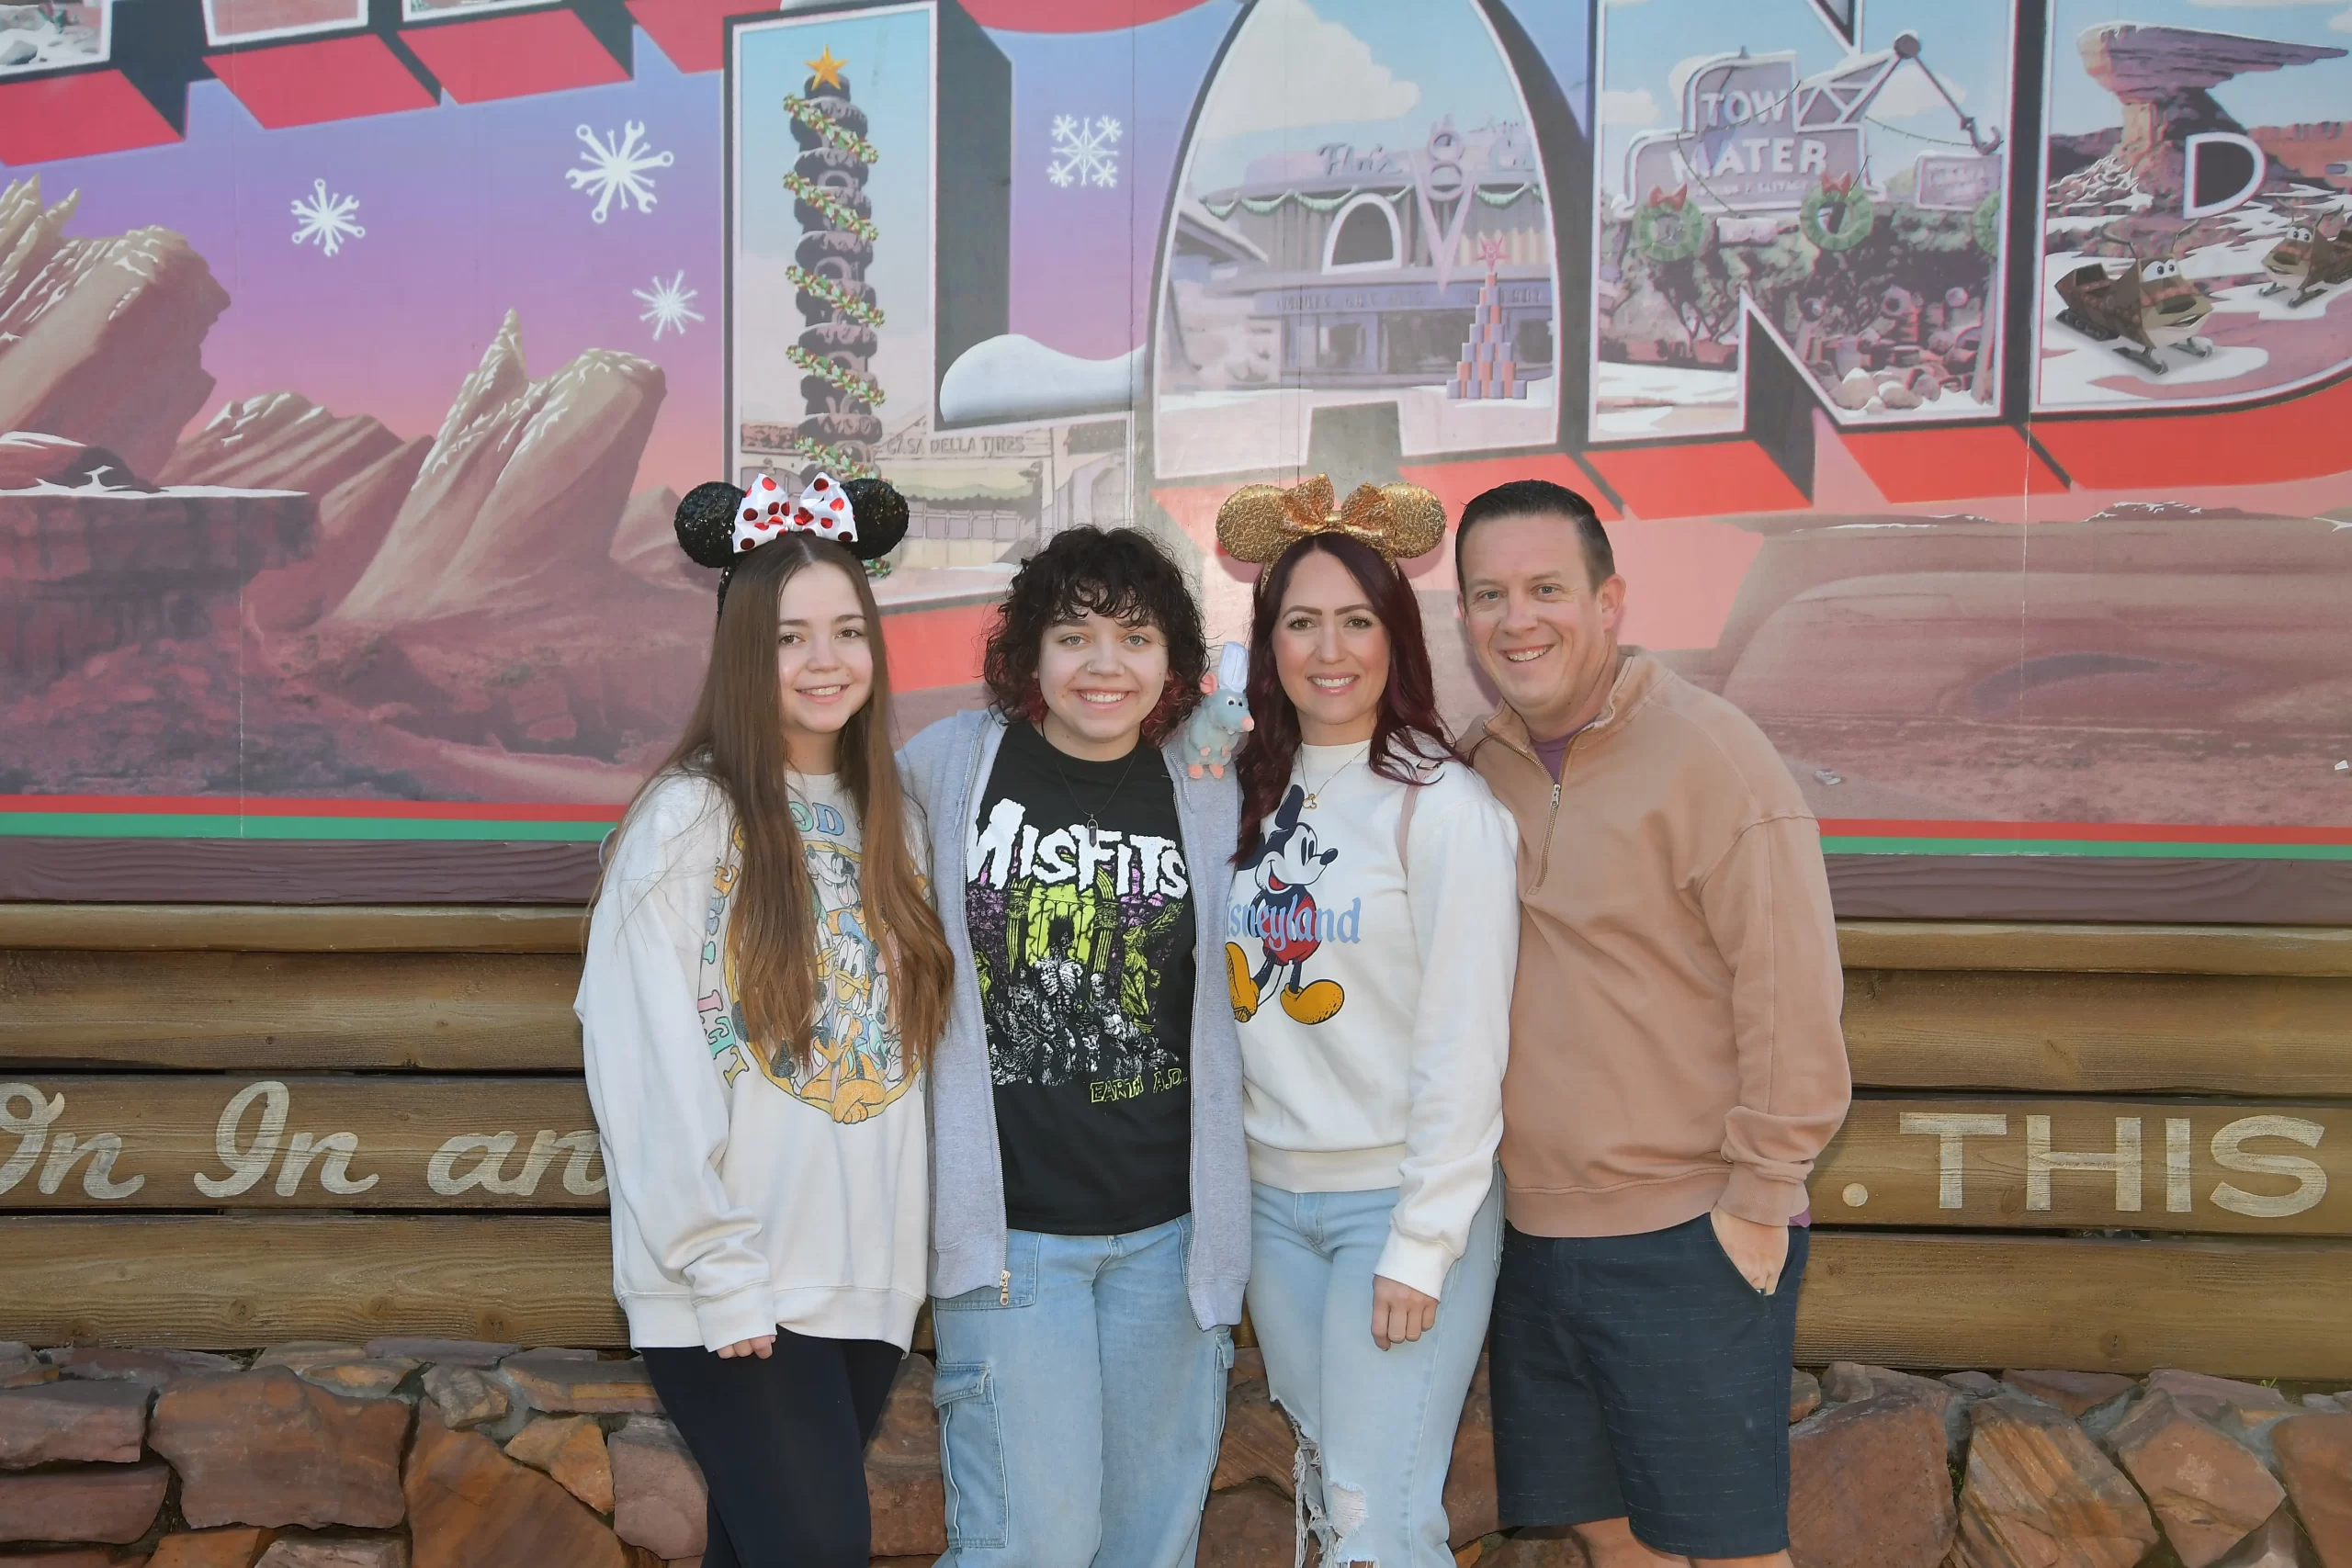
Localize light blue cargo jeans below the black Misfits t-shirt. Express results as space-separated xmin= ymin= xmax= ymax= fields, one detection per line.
xmin=932 ymin=1215 xmax=1232 ymax=1568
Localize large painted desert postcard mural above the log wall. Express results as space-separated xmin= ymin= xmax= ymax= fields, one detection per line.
xmin=0 ymin=0 xmax=2352 ymax=926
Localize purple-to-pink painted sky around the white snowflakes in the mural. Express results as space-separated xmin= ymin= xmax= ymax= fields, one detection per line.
xmin=7 ymin=7 xmax=1227 ymax=489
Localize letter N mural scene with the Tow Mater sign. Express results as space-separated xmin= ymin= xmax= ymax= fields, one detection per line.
xmin=1592 ymin=0 xmax=2008 ymax=440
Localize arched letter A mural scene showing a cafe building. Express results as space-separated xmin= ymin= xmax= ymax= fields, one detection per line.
xmin=1152 ymin=0 xmax=1559 ymax=478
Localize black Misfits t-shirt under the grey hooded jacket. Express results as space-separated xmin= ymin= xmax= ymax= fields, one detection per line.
xmin=965 ymin=724 xmax=1194 ymax=1236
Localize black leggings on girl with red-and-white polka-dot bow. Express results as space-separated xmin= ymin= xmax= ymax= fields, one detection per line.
xmin=642 ymin=1328 xmax=900 ymax=1568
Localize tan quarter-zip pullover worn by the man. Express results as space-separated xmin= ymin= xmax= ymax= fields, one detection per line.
xmin=1463 ymin=649 xmax=1851 ymax=1236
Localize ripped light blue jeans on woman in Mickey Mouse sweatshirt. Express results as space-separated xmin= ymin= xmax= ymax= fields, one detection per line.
xmin=1249 ymin=1178 xmax=1503 ymax=1568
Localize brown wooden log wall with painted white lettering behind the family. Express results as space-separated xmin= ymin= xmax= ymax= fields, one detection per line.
xmin=0 ymin=905 xmax=2352 ymax=1378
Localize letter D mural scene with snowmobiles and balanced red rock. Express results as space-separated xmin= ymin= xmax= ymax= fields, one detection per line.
xmin=2034 ymin=0 xmax=2352 ymax=409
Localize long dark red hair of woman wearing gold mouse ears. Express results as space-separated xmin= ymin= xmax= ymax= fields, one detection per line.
xmin=1232 ymin=534 xmax=1461 ymax=865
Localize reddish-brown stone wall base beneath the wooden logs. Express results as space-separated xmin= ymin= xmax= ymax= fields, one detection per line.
xmin=0 ymin=1340 xmax=2352 ymax=1568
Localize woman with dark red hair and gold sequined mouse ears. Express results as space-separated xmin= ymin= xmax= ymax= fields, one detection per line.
xmin=1221 ymin=482 xmax=1520 ymax=1568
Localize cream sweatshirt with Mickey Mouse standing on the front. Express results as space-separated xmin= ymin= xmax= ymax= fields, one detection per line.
xmin=1226 ymin=745 xmax=1520 ymax=1295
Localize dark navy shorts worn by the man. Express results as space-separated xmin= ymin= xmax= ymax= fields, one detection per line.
xmin=1491 ymin=1215 xmax=1811 ymax=1556
